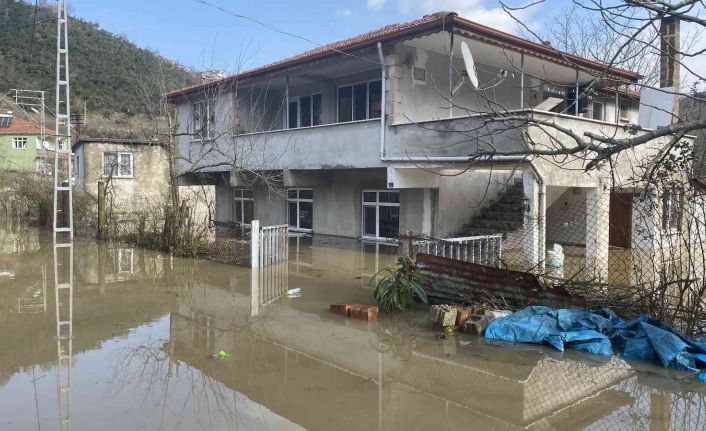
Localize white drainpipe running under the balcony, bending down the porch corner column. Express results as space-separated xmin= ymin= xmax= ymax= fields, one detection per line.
xmin=380 ymin=156 xmax=547 ymax=272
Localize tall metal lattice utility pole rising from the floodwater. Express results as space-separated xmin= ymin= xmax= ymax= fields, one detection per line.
xmin=54 ymin=0 xmax=74 ymax=239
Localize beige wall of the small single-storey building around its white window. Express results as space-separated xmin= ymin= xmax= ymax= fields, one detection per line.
xmin=80 ymin=143 xmax=169 ymax=207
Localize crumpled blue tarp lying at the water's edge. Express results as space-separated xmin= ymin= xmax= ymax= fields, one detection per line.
xmin=485 ymin=306 xmax=706 ymax=380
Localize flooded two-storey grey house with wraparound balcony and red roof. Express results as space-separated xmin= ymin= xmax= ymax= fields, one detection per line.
xmin=166 ymin=12 xmax=688 ymax=284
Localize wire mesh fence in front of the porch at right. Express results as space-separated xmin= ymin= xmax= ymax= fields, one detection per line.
xmin=404 ymin=179 xmax=706 ymax=333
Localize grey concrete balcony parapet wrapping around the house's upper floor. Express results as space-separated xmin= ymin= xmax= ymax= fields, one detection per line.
xmin=175 ymin=110 xmax=656 ymax=180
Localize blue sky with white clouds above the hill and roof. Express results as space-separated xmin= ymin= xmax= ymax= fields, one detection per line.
xmin=69 ymin=0 xmax=706 ymax=88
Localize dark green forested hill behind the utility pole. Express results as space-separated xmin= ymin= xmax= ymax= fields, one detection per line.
xmin=0 ymin=0 xmax=197 ymax=117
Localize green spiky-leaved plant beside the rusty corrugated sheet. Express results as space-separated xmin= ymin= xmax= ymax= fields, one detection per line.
xmin=373 ymin=256 xmax=427 ymax=311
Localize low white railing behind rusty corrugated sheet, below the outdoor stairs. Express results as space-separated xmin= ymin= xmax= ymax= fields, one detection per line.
xmin=414 ymin=234 xmax=503 ymax=267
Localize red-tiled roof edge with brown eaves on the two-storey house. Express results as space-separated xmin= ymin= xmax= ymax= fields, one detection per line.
xmin=165 ymin=12 xmax=641 ymax=100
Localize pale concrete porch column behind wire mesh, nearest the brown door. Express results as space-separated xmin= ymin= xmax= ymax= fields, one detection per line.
xmin=586 ymin=183 xmax=610 ymax=283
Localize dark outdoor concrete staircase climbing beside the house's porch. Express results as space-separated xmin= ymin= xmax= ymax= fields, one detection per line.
xmin=455 ymin=179 xmax=525 ymax=237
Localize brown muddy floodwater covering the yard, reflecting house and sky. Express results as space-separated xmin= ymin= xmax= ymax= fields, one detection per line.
xmin=0 ymin=228 xmax=706 ymax=431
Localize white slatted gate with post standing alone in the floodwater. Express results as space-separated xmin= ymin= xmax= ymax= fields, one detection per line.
xmin=250 ymin=220 xmax=289 ymax=268
